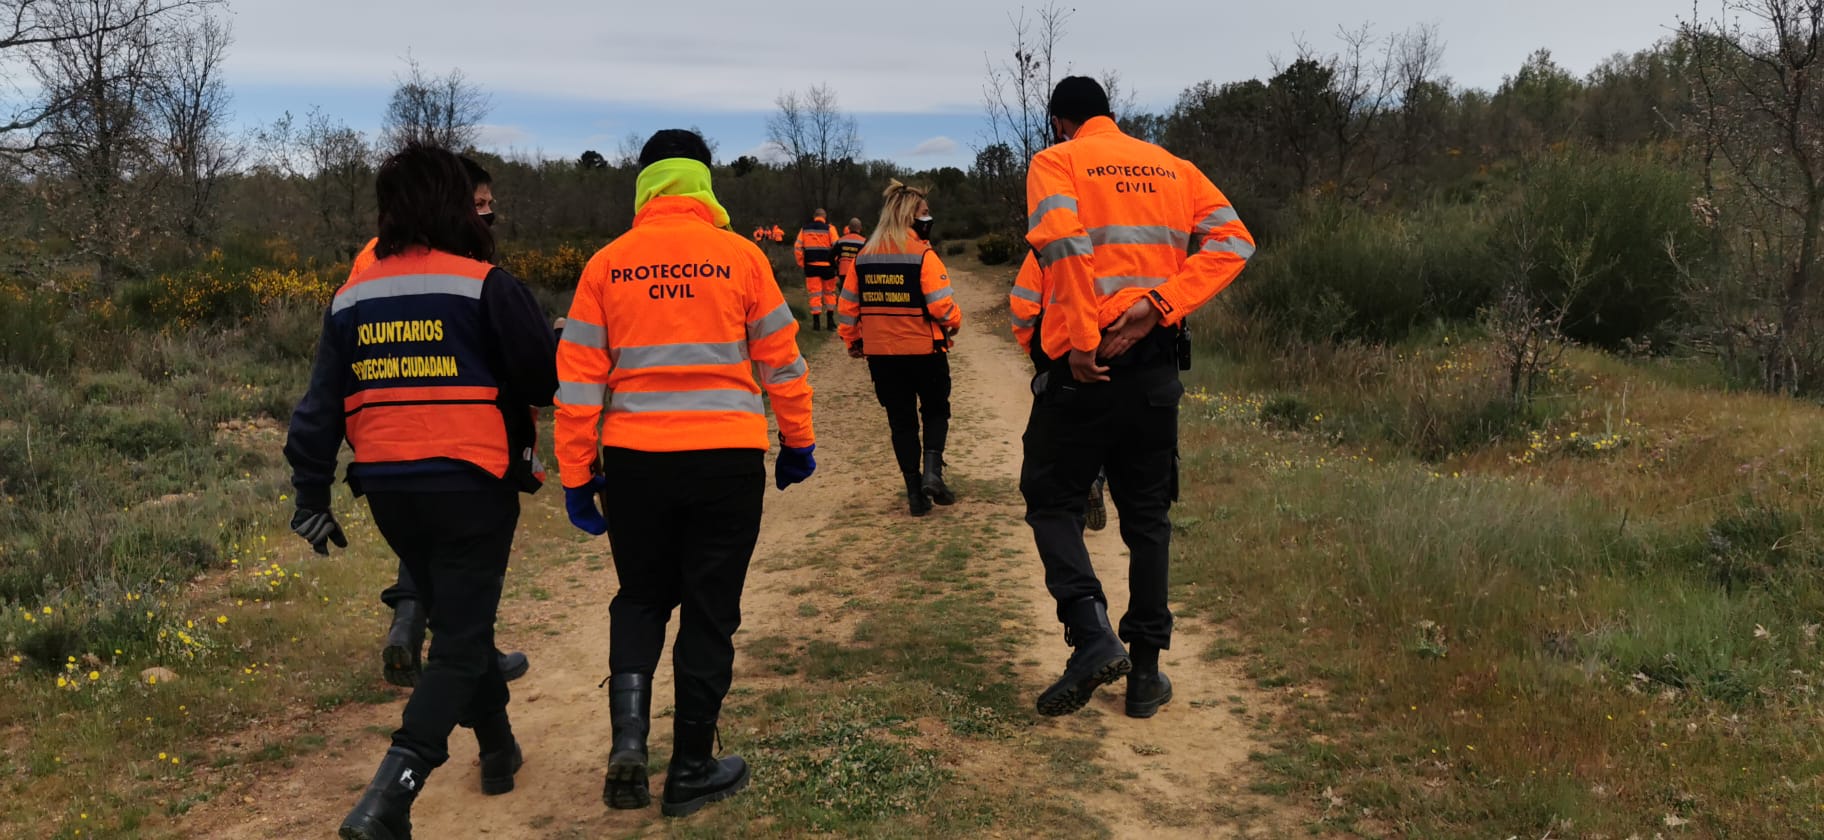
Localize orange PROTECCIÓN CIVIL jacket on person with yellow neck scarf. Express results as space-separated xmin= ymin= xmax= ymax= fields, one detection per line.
xmin=556 ymin=195 xmax=815 ymax=487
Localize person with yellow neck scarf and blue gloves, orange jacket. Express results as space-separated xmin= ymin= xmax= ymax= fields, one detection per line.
xmin=556 ymin=129 xmax=817 ymax=816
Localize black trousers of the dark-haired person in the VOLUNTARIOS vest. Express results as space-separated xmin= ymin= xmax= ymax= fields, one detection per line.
xmin=367 ymin=483 xmax=520 ymax=767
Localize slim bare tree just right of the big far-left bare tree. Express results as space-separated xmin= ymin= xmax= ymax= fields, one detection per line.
xmin=151 ymin=15 xmax=243 ymax=246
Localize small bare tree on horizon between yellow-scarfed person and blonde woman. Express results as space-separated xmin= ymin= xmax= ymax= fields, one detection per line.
xmin=766 ymin=84 xmax=861 ymax=215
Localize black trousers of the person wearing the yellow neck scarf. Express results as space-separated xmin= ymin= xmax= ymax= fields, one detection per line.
xmin=602 ymin=448 xmax=766 ymax=722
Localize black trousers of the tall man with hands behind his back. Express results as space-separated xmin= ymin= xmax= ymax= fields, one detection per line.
xmin=1020 ymin=359 xmax=1184 ymax=649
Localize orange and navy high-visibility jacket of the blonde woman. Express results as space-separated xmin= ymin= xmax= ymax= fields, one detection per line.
xmin=835 ymin=237 xmax=963 ymax=355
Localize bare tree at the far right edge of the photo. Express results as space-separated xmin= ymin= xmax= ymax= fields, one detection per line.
xmin=1680 ymin=0 xmax=1824 ymax=392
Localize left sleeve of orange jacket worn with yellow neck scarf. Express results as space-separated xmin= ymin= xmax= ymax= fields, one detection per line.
xmin=554 ymin=255 xmax=613 ymax=487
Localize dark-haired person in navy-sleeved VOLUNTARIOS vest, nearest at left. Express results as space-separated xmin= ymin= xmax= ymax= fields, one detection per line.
xmin=285 ymin=144 xmax=556 ymax=840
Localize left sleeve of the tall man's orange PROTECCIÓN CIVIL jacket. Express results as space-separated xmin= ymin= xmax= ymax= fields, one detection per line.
xmin=1027 ymin=149 xmax=1102 ymax=352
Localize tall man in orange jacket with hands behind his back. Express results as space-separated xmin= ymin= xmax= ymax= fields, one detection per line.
xmin=1020 ymin=77 xmax=1255 ymax=718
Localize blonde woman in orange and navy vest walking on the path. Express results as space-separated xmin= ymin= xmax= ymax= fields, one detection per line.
xmin=835 ymin=180 xmax=963 ymax=516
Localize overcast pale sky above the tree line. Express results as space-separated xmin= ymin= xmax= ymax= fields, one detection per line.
xmin=228 ymin=0 xmax=1716 ymax=168
